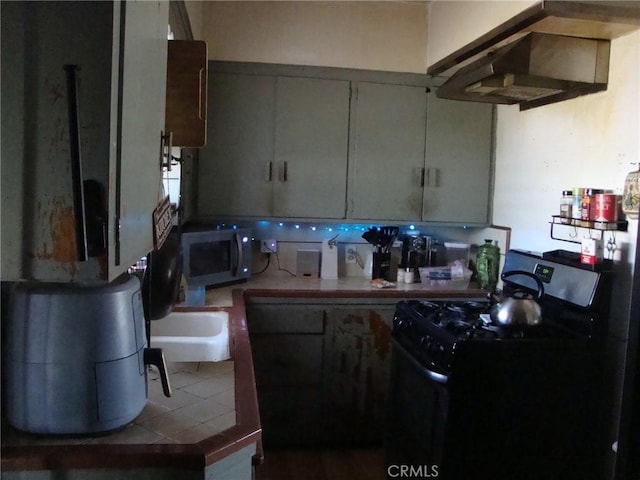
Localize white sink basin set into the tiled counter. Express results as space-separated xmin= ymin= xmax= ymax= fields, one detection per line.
xmin=151 ymin=311 xmax=230 ymax=362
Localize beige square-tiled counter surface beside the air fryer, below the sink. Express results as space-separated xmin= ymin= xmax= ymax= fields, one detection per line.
xmin=2 ymin=360 xmax=236 ymax=445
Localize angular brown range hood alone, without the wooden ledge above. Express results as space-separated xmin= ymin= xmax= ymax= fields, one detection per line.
xmin=436 ymin=33 xmax=610 ymax=110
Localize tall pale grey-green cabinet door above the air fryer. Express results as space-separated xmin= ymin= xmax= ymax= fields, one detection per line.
xmin=114 ymin=1 xmax=169 ymax=280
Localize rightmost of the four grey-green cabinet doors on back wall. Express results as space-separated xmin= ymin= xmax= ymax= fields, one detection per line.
xmin=422 ymin=92 xmax=493 ymax=224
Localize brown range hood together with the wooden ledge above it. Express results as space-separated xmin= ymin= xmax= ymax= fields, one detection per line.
xmin=427 ymin=0 xmax=640 ymax=110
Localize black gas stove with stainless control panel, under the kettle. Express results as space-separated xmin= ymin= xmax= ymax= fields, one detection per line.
xmin=386 ymin=250 xmax=611 ymax=480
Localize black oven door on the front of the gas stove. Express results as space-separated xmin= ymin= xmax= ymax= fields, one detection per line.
xmin=385 ymin=338 xmax=449 ymax=476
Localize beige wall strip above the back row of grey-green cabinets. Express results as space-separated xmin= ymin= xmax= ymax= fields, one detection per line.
xmin=195 ymin=1 xmax=427 ymax=73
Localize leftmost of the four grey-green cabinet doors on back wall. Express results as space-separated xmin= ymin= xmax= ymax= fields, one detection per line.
xmin=197 ymin=73 xmax=276 ymax=217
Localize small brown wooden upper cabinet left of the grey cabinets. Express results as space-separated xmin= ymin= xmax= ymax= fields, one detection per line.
xmin=165 ymin=40 xmax=208 ymax=147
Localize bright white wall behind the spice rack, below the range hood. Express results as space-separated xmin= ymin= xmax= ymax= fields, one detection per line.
xmin=494 ymin=32 xmax=640 ymax=253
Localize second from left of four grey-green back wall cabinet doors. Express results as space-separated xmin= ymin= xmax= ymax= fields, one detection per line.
xmin=273 ymin=77 xmax=350 ymax=218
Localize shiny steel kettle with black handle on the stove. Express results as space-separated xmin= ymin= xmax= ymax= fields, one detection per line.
xmin=491 ymin=270 xmax=544 ymax=328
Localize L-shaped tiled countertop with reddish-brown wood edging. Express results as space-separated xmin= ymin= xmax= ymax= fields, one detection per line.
xmin=1 ymin=272 xmax=486 ymax=471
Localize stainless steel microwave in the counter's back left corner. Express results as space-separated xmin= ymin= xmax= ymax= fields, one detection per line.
xmin=181 ymin=225 xmax=251 ymax=286
